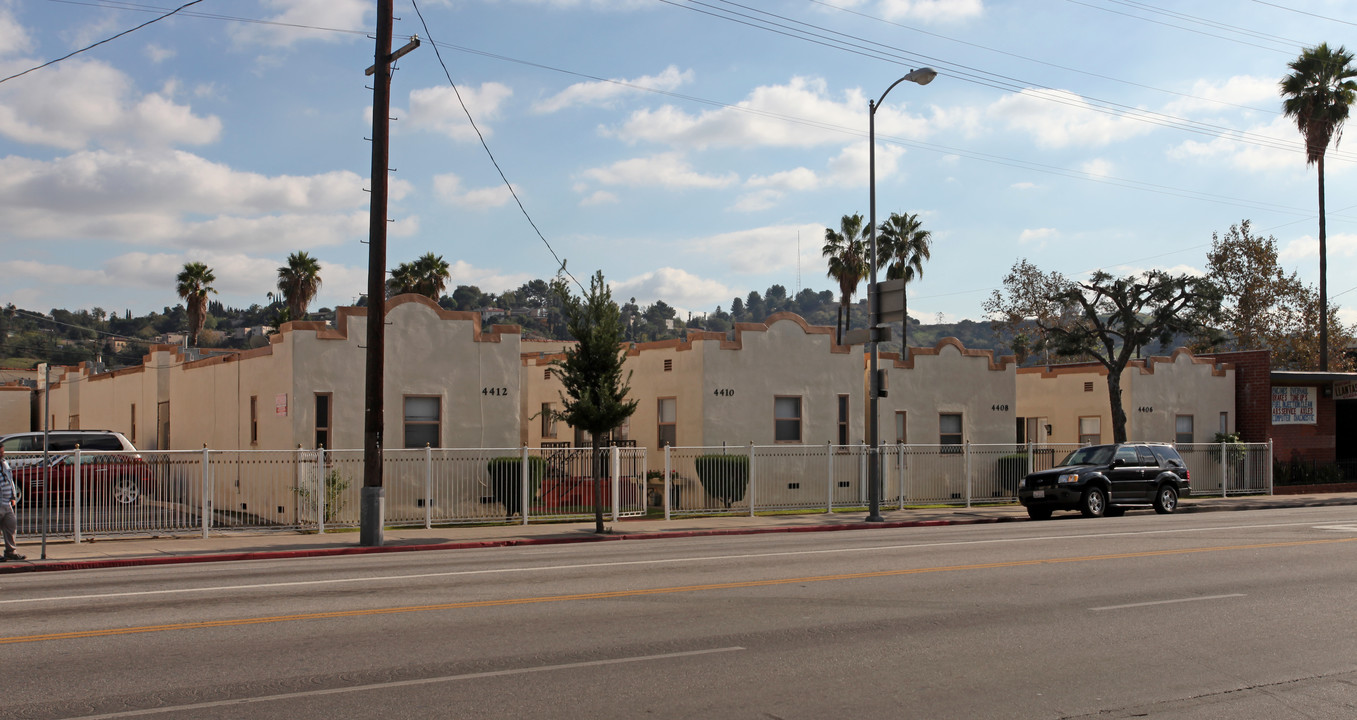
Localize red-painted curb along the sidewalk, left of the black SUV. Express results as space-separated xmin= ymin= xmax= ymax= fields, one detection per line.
xmin=0 ymin=517 xmax=1027 ymax=575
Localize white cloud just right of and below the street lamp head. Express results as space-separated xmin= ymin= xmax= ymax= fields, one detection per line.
xmin=987 ymin=88 xmax=1153 ymax=148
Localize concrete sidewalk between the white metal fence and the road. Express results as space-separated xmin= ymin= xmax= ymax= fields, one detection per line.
xmin=0 ymin=492 xmax=1357 ymax=574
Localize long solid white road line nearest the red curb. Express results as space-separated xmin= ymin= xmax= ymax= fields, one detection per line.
xmin=0 ymin=522 xmax=1346 ymax=606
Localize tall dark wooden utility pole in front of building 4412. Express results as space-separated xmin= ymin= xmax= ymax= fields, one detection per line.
xmin=358 ymin=0 xmax=419 ymax=546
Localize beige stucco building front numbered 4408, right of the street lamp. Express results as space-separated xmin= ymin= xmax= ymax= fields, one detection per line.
xmin=878 ymin=338 xmax=1018 ymax=445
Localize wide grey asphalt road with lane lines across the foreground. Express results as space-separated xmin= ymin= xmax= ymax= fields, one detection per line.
xmin=0 ymin=507 xmax=1357 ymax=720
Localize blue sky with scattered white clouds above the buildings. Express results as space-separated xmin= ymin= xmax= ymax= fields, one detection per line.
xmin=0 ymin=0 xmax=1357 ymax=323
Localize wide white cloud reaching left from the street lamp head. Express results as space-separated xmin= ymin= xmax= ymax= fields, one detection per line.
xmin=608 ymin=77 xmax=931 ymax=149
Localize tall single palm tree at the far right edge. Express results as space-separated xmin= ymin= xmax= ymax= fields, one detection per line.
xmin=1281 ymin=42 xmax=1357 ymax=372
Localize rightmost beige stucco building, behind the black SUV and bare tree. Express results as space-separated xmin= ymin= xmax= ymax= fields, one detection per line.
xmin=1016 ymin=348 xmax=1235 ymax=443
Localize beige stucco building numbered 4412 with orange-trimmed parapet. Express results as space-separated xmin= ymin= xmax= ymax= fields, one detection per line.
xmin=35 ymin=296 xmax=520 ymax=450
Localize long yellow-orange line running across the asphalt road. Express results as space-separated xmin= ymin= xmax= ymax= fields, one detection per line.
xmin=0 ymin=537 xmax=1357 ymax=645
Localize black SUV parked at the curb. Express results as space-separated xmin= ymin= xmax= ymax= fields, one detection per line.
xmin=1018 ymin=442 xmax=1191 ymax=519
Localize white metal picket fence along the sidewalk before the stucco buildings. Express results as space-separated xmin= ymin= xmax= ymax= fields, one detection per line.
xmin=8 ymin=443 xmax=1273 ymax=541
